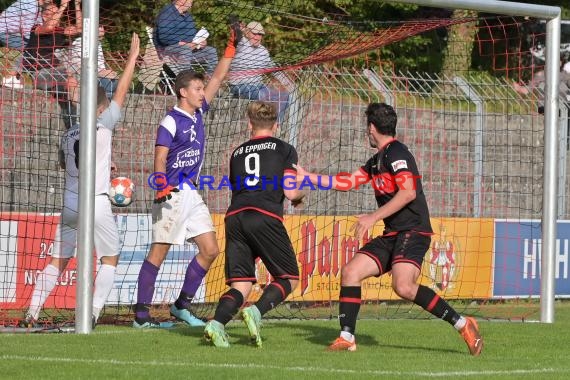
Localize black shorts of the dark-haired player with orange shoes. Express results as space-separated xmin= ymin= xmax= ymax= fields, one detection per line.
xmin=357 ymin=231 xmax=431 ymax=276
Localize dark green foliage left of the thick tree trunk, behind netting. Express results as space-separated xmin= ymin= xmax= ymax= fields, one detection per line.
xmin=95 ymin=0 xmax=444 ymax=71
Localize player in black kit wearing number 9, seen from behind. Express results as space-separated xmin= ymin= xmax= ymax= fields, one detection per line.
xmin=204 ymin=101 xmax=304 ymax=347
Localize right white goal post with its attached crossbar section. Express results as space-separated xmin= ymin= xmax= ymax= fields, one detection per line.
xmin=382 ymin=0 xmax=561 ymax=323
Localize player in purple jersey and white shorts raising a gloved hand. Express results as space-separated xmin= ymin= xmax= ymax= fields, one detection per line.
xmin=133 ymin=24 xmax=241 ymax=328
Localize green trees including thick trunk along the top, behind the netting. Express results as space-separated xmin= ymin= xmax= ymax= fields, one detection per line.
xmin=0 ymin=0 xmax=570 ymax=75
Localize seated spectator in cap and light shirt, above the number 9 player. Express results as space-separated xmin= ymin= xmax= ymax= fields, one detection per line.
xmin=230 ymin=21 xmax=295 ymax=123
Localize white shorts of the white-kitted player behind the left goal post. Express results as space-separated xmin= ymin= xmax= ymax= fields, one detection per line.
xmin=53 ymin=194 xmax=119 ymax=259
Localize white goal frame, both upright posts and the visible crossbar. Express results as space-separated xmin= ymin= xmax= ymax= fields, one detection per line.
xmin=71 ymin=0 xmax=561 ymax=334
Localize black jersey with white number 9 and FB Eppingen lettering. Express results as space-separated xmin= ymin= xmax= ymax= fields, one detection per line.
xmin=226 ymin=136 xmax=297 ymax=219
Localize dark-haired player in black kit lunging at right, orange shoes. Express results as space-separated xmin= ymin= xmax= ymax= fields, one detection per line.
xmin=297 ymin=103 xmax=483 ymax=355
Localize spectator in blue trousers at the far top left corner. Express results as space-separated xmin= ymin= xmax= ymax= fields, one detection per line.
xmin=0 ymin=0 xmax=48 ymax=89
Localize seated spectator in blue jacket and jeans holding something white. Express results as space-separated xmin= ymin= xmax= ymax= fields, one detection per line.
xmin=154 ymin=0 xmax=218 ymax=74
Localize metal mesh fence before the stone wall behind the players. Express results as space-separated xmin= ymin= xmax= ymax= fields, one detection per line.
xmin=0 ymin=68 xmax=569 ymax=219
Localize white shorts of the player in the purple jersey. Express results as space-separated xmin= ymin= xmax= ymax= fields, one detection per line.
xmin=152 ymin=189 xmax=215 ymax=244
